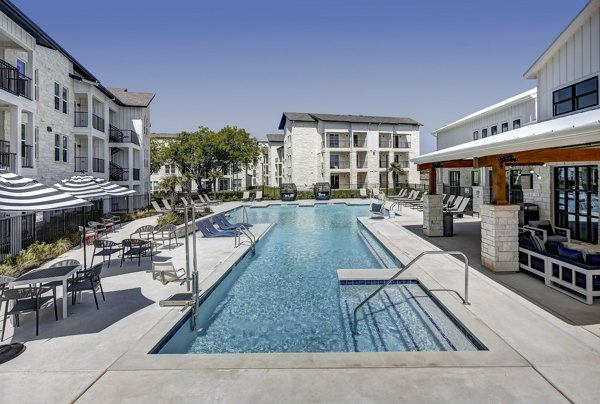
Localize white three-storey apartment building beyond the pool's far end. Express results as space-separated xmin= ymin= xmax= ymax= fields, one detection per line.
xmin=279 ymin=112 xmax=421 ymax=189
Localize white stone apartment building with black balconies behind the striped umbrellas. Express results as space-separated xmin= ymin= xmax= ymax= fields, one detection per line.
xmin=0 ymin=0 xmax=154 ymax=199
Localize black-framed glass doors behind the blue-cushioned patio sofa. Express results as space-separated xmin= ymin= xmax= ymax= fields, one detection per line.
xmin=554 ymin=165 xmax=598 ymax=244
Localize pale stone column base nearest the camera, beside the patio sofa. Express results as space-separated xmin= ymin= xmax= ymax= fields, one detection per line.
xmin=481 ymin=204 xmax=519 ymax=272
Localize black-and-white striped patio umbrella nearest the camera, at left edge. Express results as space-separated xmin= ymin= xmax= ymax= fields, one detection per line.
xmin=0 ymin=171 xmax=90 ymax=212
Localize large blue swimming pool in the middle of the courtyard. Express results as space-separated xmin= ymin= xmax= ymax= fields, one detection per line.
xmin=157 ymin=204 xmax=478 ymax=353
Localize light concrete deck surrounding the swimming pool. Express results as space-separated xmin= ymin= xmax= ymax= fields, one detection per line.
xmin=0 ymin=199 xmax=600 ymax=403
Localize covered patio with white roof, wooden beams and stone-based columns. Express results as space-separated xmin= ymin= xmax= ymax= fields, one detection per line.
xmin=412 ymin=109 xmax=600 ymax=272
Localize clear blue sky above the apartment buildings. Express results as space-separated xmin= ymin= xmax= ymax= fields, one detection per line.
xmin=13 ymin=0 xmax=586 ymax=152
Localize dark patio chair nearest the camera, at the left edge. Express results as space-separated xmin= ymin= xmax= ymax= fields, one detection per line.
xmin=0 ymin=286 xmax=58 ymax=341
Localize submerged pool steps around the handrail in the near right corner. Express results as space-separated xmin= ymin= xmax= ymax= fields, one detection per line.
xmin=340 ymin=283 xmax=472 ymax=352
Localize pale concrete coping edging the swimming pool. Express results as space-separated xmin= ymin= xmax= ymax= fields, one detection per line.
xmin=109 ymin=207 xmax=531 ymax=370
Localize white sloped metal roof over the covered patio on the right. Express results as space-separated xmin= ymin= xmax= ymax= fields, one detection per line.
xmin=411 ymin=109 xmax=600 ymax=164
